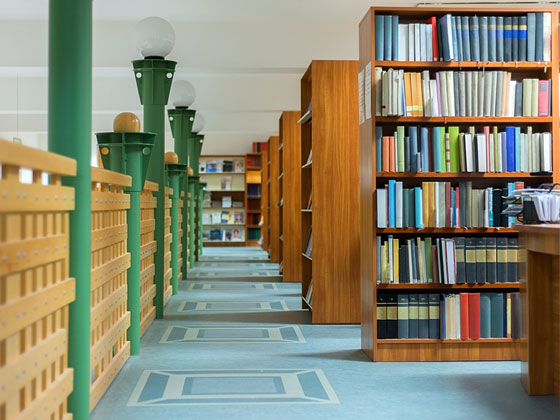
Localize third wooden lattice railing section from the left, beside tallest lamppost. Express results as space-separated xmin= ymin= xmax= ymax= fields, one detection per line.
xmin=140 ymin=181 xmax=159 ymax=334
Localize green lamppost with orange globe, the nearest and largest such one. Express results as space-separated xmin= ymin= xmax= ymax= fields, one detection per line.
xmin=95 ymin=112 xmax=156 ymax=355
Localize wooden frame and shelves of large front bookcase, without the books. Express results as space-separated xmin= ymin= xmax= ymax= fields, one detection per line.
xmin=359 ymin=7 xmax=560 ymax=361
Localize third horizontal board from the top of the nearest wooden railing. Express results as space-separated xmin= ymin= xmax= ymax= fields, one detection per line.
xmin=0 ymin=235 xmax=68 ymax=276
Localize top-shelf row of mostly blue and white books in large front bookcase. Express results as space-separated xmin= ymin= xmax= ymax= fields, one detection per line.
xmin=375 ymin=12 xmax=552 ymax=62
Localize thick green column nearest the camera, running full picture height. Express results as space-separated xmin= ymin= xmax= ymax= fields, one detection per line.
xmin=48 ymin=0 xmax=92 ymax=420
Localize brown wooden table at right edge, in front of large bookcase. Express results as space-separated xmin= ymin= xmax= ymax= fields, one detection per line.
xmin=515 ymin=224 xmax=560 ymax=397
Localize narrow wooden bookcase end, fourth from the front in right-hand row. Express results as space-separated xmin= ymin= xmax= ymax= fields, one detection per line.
xmin=268 ymin=136 xmax=282 ymax=264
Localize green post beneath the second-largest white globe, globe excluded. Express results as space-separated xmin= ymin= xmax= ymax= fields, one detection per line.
xmin=167 ymin=107 xmax=196 ymax=279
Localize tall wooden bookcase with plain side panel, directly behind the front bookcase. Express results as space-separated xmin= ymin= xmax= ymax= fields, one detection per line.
xmin=300 ymin=60 xmax=360 ymax=324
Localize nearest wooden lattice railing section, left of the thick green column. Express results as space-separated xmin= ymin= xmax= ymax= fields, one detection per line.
xmin=0 ymin=140 xmax=76 ymax=420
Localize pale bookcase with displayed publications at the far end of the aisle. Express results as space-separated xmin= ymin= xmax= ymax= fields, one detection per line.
xmin=199 ymin=155 xmax=247 ymax=246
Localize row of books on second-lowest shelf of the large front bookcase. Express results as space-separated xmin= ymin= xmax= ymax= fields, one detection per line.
xmin=376 ymin=235 xmax=519 ymax=284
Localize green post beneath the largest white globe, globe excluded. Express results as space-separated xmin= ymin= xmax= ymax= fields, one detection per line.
xmin=132 ymin=58 xmax=177 ymax=319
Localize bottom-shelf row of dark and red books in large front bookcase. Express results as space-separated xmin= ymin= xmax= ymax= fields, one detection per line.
xmin=376 ymin=292 xmax=521 ymax=340
